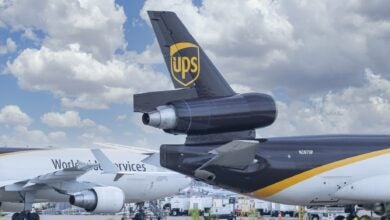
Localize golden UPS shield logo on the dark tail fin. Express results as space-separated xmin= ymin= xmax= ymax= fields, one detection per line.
xmin=169 ymin=42 xmax=200 ymax=87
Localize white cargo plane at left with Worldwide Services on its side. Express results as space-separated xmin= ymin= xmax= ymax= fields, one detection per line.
xmin=0 ymin=147 xmax=190 ymax=220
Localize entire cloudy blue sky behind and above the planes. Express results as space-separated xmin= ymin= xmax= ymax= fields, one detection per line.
xmin=0 ymin=0 xmax=390 ymax=148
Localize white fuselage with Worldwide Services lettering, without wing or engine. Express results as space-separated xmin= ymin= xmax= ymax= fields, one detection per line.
xmin=0 ymin=148 xmax=191 ymax=202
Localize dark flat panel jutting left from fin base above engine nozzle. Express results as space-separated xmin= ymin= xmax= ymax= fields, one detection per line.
xmin=134 ymin=88 xmax=198 ymax=113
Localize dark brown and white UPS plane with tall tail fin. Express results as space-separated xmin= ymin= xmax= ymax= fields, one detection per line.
xmin=134 ymin=11 xmax=390 ymax=218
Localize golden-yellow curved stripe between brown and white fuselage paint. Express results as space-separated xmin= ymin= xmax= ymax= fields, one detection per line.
xmin=250 ymin=148 xmax=390 ymax=198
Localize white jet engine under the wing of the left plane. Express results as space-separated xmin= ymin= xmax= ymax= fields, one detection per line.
xmin=69 ymin=186 xmax=125 ymax=213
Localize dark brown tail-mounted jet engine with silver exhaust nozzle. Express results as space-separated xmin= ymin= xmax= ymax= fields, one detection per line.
xmin=142 ymin=93 xmax=276 ymax=134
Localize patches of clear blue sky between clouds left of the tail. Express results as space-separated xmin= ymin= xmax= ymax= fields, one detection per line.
xmin=0 ymin=0 xmax=177 ymax=146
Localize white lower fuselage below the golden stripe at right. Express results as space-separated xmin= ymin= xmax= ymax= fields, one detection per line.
xmin=250 ymin=150 xmax=390 ymax=205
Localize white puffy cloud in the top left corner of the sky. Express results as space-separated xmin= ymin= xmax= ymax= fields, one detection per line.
xmin=0 ymin=0 xmax=126 ymax=60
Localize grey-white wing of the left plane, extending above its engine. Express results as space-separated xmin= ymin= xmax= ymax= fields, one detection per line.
xmin=0 ymin=163 xmax=98 ymax=194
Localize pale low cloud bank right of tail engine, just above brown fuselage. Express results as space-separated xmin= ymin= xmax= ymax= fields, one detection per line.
xmin=257 ymin=69 xmax=390 ymax=136
